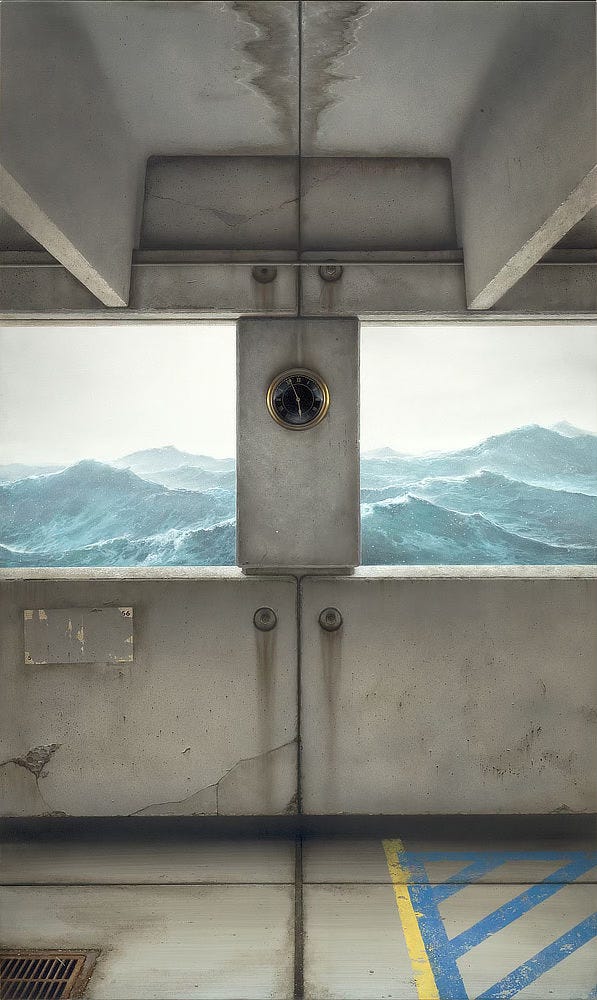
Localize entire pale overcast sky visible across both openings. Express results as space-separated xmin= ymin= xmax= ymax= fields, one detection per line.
xmin=0 ymin=323 xmax=597 ymax=464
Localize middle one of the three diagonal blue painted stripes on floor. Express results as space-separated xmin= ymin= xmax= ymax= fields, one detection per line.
xmin=450 ymin=860 xmax=593 ymax=958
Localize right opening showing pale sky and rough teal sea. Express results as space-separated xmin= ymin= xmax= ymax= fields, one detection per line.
xmin=361 ymin=323 xmax=597 ymax=565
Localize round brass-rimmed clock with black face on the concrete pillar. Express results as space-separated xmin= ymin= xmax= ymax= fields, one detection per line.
xmin=266 ymin=368 xmax=330 ymax=431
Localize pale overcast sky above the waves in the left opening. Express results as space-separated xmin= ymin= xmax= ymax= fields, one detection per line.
xmin=0 ymin=323 xmax=236 ymax=464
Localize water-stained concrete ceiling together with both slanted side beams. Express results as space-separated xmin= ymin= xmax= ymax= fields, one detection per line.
xmin=0 ymin=0 xmax=597 ymax=309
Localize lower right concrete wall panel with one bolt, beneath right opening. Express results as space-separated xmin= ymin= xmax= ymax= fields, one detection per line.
xmin=301 ymin=577 xmax=597 ymax=814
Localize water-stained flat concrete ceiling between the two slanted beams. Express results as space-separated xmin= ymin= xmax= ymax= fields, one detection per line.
xmin=60 ymin=0 xmax=591 ymax=156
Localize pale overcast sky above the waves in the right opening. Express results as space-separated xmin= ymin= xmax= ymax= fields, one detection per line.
xmin=361 ymin=323 xmax=597 ymax=454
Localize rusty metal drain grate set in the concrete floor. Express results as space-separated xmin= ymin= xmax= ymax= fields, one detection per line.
xmin=0 ymin=950 xmax=98 ymax=1000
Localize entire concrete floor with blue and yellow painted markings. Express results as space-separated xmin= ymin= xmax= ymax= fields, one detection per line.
xmin=0 ymin=821 xmax=597 ymax=1000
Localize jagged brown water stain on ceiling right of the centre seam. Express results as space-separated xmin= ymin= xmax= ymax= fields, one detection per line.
xmin=301 ymin=0 xmax=376 ymax=152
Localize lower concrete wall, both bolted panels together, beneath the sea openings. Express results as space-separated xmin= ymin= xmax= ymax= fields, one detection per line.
xmin=0 ymin=567 xmax=597 ymax=816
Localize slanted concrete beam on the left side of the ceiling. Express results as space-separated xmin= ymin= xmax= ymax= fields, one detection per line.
xmin=0 ymin=0 xmax=143 ymax=306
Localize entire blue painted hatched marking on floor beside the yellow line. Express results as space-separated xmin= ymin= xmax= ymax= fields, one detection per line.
xmin=392 ymin=851 xmax=597 ymax=1000
